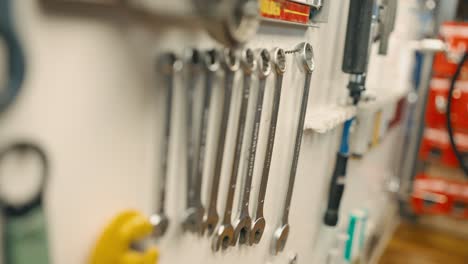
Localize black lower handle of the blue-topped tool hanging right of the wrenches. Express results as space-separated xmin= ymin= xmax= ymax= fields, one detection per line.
xmin=323 ymin=153 xmax=348 ymax=226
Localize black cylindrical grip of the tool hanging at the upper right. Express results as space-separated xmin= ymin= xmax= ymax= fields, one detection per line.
xmin=342 ymin=0 xmax=374 ymax=74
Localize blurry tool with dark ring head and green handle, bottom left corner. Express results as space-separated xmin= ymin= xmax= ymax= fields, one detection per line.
xmin=0 ymin=142 xmax=50 ymax=264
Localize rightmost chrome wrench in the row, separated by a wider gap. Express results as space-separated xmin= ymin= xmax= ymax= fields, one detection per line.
xmin=272 ymin=42 xmax=315 ymax=255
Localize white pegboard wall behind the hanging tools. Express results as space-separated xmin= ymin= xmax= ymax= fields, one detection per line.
xmin=0 ymin=1 xmax=424 ymax=264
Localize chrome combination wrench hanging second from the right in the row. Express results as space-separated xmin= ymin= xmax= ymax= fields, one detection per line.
xmin=249 ymin=48 xmax=286 ymax=245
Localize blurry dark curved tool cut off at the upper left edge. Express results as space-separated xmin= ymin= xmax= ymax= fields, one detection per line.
xmin=0 ymin=0 xmax=26 ymax=112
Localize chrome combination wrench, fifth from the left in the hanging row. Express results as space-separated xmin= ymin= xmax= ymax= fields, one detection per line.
xmin=213 ymin=49 xmax=257 ymax=251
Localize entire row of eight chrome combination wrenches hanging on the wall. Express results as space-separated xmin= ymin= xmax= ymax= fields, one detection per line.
xmin=151 ymin=43 xmax=314 ymax=254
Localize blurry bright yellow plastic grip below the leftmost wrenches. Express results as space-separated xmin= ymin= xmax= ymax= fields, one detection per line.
xmin=89 ymin=210 xmax=159 ymax=264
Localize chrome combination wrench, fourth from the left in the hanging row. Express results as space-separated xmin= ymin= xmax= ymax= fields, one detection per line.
xmin=202 ymin=49 xmax=240 ymax=235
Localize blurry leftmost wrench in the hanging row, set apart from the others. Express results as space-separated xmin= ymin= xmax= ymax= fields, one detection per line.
xmin=150 ymin=53 xmax=183 ymax=238
